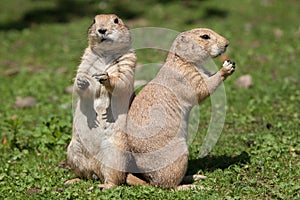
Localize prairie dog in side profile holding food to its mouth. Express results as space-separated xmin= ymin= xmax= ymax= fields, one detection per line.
xmin=126 ymin=28 xmax=235 ymax=188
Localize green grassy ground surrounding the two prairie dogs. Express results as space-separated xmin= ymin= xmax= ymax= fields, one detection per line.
xmin=0 ymin=0 xmax=300 ymax=199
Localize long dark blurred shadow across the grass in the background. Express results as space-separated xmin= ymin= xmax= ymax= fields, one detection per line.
xmin=0 ymin=0 xmax=227 ymax=31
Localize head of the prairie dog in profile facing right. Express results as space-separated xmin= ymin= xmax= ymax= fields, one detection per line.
xmin=171 ymin=28 xmax=229 ymax=65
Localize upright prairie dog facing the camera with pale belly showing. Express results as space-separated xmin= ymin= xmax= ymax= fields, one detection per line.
xmin=67 ymin=14 xmax=136 ymax=188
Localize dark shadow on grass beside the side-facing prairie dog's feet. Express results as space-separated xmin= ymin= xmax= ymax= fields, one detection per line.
xmin=187 ymin=151 xmax=250 ymax=175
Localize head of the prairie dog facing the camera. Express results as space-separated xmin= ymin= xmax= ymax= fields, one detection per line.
xmin=88 ymin=14 xmax=131 ymax=51
